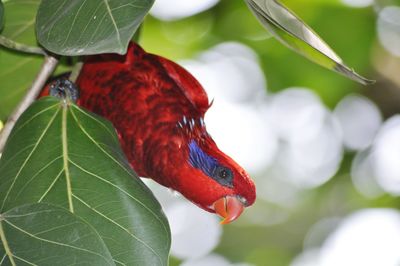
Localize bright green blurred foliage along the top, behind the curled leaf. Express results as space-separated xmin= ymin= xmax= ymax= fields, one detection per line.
xmin=141 ymin=0 xmax=375 ymax=107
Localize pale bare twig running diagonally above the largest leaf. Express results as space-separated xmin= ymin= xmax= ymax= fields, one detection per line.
xmin=0 ymin=55 xmax=58 ymax=153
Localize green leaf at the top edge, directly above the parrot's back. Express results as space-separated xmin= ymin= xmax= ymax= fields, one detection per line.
xmin=36 ymin=0 xmax=154 ymax=55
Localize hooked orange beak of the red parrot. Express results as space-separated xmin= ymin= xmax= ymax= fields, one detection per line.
xmin=213 ymin=196 xmax=245 ymax=224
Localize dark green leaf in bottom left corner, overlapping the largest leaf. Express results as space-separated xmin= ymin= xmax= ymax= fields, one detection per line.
xmin=0 ymin=203 xmax=115 ymax=265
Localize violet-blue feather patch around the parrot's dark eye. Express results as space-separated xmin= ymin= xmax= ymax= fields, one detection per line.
xmin=189 ymin=140 xmax=233 ymax=188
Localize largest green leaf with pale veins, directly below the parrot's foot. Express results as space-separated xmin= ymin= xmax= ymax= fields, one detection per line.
xmin=0 ymin=97 xmax=170 ymax=265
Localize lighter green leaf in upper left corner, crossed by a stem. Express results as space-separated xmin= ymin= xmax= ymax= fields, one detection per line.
xmin=0 ymin=0 xmax=43 ymax=120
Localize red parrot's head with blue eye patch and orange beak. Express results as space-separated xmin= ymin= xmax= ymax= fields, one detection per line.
xmin=163 ymin=119 xmax=256 ymax=224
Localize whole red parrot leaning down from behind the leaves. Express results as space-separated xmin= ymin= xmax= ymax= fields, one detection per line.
xmin=43 ymin=43 xmax=256 ymax=224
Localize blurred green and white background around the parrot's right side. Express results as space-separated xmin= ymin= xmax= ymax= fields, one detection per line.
xmin=140 ymin=0 xmax=400 ymax=266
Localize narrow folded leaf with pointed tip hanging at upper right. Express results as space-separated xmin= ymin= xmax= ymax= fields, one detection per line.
xmin=246 ymin=0 xmax=373 ymax=85
